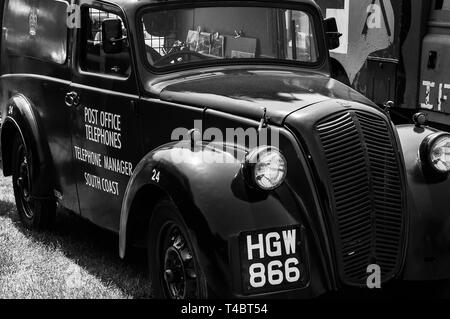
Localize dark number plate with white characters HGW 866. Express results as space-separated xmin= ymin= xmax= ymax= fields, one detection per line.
xmin=239 ymin=226 xmax=307 ymax=294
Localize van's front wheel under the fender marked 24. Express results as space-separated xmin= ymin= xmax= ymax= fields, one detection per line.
xmin=147 ymin=200 xmax=207 ymax=300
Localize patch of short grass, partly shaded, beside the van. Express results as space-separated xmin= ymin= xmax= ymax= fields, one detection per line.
xmin=0 ymin=171 xmax=151 ymax=299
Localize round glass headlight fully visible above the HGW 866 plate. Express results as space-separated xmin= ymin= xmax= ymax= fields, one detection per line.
xmin=244 ymin=146 xmax=287 ymax=190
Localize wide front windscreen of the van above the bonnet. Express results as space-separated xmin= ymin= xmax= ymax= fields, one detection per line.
xmin=141 ymin=7 xmax=319 ymax=68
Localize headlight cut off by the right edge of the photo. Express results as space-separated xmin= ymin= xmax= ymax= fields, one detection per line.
xmin=420 ymin=133 xmax=450 ymax=174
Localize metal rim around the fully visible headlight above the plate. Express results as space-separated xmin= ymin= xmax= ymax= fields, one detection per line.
xmin=243 ymin=146 xmax=288 ymax=191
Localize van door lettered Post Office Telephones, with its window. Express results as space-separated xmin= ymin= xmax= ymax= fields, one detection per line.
xmin=66 ymin=4 xmax=140 ymax=231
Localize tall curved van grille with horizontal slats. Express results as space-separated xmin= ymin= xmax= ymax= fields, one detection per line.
xmin=317 ymin=111 xmax=405 ymax=285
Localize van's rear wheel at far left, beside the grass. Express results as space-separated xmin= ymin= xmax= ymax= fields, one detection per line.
xmin=12 ymin=134 xmax=56 ymax=230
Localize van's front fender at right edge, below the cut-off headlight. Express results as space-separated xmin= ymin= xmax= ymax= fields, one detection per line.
xmin=398 ymin=125 xmax=450 ymax=280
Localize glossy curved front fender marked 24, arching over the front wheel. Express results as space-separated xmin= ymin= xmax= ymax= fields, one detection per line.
xmin=120 ymin=143 xmax=318 ymax=297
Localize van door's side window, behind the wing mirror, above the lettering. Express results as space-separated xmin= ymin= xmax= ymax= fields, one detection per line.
xmin=80 ymin=8 xmax=131 ymax=77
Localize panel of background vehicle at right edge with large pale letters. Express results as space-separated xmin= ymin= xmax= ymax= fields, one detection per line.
xmin=419 ymin=0 xmax=450 ymax=125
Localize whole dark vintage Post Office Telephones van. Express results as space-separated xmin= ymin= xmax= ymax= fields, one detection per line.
xmin=0 ymin=0 xmax=450 ymax=298
